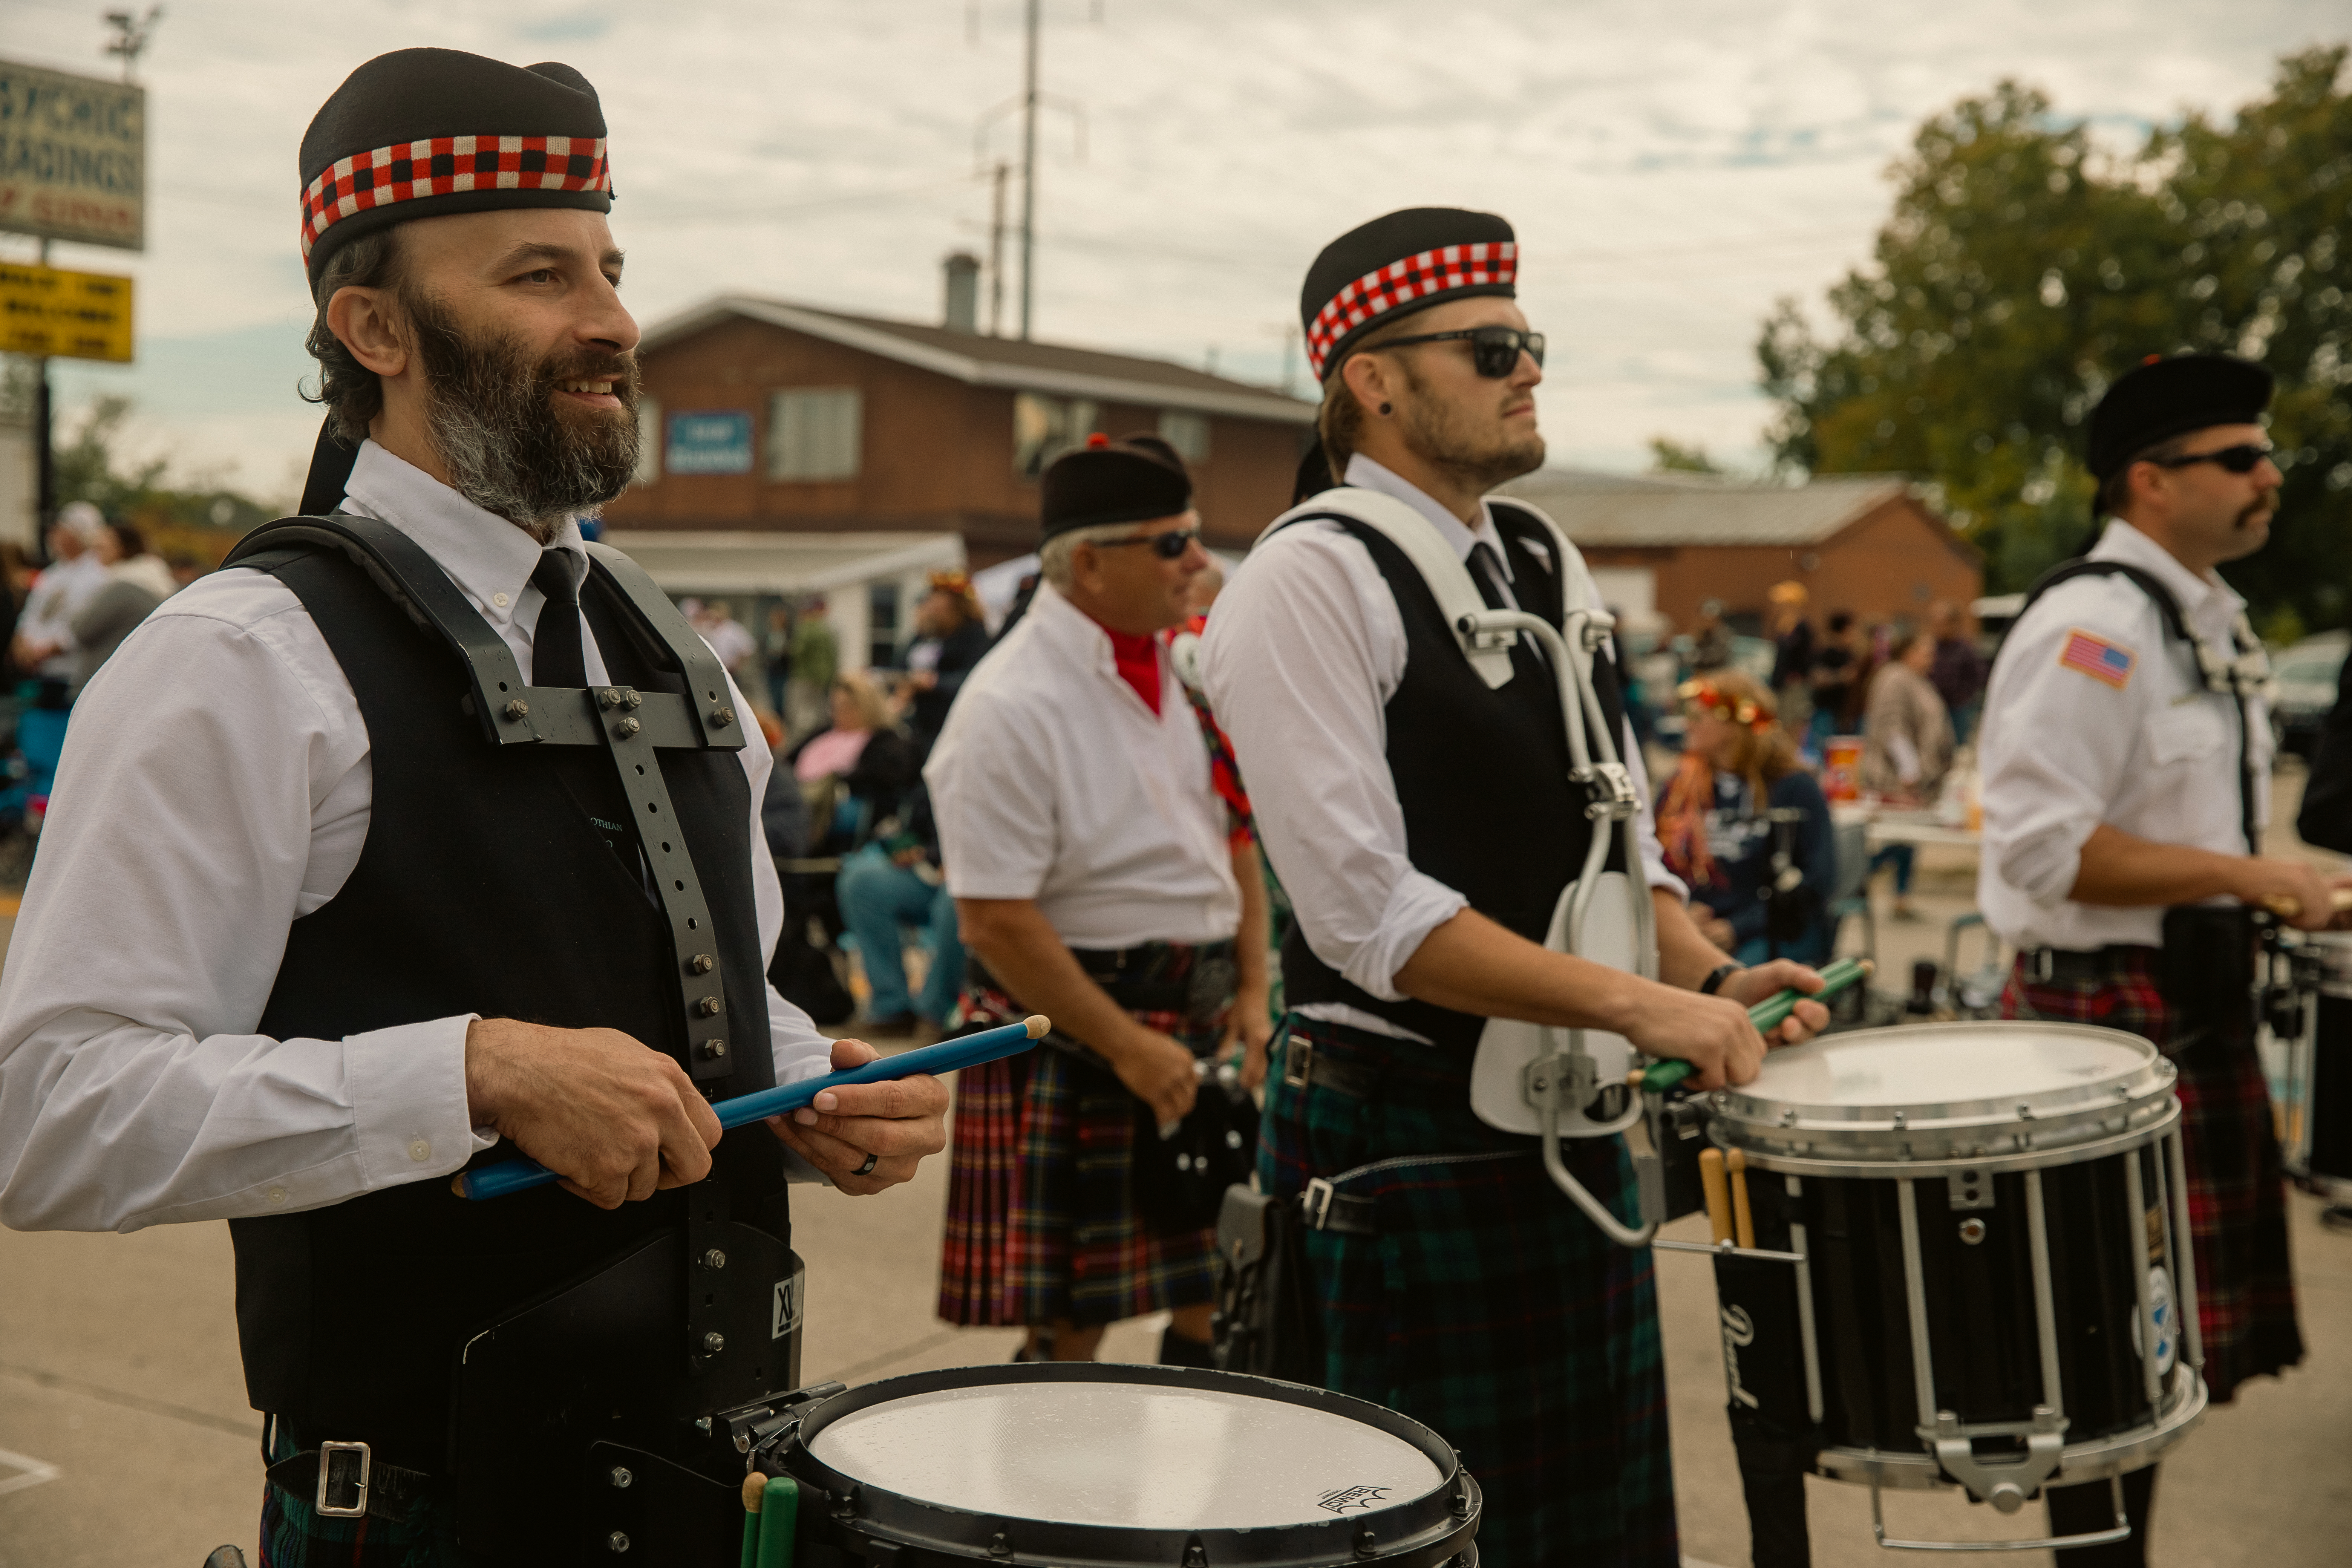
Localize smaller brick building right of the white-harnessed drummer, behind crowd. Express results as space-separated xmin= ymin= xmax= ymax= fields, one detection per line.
xmin=1503 ymin=468 xmax=1985 ymax=632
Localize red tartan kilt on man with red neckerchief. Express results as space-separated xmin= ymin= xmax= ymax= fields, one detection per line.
xmin=939 ymin=943 xmax=1233 ymax=1328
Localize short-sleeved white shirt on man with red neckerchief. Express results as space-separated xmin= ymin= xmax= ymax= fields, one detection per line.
xmin=922 ymin=583 xmax=1242 ymax=947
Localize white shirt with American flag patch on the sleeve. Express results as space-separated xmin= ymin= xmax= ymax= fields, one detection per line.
xmin=1976 ymin=522 xmax=2272 ymax=950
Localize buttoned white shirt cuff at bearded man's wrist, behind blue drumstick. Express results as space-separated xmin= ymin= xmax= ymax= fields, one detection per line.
xmin=343 ymin=1013 xmax=496 ymax=1192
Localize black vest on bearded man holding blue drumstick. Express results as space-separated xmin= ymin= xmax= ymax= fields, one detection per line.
xmin=231 ymin=550 xmax=790 ymax=1469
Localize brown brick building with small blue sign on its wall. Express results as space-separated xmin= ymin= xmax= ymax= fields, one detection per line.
xmin=605 ymin=290 xmax=1315 ymax=567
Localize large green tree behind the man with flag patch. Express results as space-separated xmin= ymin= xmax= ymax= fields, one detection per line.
xmin=1757 ymin=47 xmax=2352 ymax=625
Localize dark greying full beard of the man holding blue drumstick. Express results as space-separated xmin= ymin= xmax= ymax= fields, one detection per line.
xmin=404 ymin=296 xmax=637 ymax=543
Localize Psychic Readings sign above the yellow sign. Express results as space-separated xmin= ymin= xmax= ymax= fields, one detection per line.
xmin=0 ymin=61 xmax=146 ymax=251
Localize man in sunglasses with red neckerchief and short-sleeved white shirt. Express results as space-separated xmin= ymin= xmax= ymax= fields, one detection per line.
xmin=924 ymin=435 xmax=1272 ymax=1366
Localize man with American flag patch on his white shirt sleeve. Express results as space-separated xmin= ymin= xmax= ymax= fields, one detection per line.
xmin=1978 ymin=355 xmax=2331 ymax=1568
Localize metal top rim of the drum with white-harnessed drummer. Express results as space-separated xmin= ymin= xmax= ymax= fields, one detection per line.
xmin=1710 ymin=1018 xmax=2176 ymax=1147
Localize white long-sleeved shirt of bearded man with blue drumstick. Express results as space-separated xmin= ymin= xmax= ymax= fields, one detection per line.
xmin=0 ymin=442 xmax=830 ymax=1230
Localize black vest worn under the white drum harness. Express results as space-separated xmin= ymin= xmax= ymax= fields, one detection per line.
xmin=1279 ymin=501 xmax=1625 ymax=1046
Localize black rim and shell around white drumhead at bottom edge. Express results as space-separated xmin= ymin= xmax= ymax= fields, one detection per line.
xmin=755 ymin=1361 xmax=1482 ymax=1568
